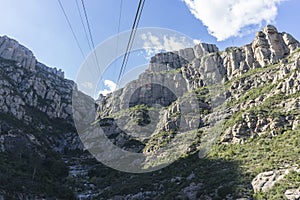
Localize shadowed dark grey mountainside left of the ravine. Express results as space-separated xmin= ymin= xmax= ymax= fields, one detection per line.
xmin=0 ymin=36 xmax=92 ymax=199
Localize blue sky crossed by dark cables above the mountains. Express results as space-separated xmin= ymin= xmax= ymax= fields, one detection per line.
xmin=0 ymin=0 xmax=300 ymax=97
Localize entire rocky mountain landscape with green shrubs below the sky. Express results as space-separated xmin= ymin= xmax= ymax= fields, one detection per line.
xmin=0 ymin=25 xmax=300 ymax=199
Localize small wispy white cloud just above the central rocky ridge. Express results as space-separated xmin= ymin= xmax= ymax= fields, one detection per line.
xmin=141 ymin=32 xmax=200 ymax=59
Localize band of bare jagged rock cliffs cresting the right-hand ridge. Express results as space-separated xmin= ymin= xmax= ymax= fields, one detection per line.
xmin=148 ymin=25 xmax=300 ymax=79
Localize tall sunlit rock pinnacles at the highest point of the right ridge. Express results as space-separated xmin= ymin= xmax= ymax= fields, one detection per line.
xmin=221 ymin=25 xmax=300 ymax=79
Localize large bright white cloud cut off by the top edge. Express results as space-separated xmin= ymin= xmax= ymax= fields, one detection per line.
xmin=183 ymin=0 xmax=284 ymax=41
